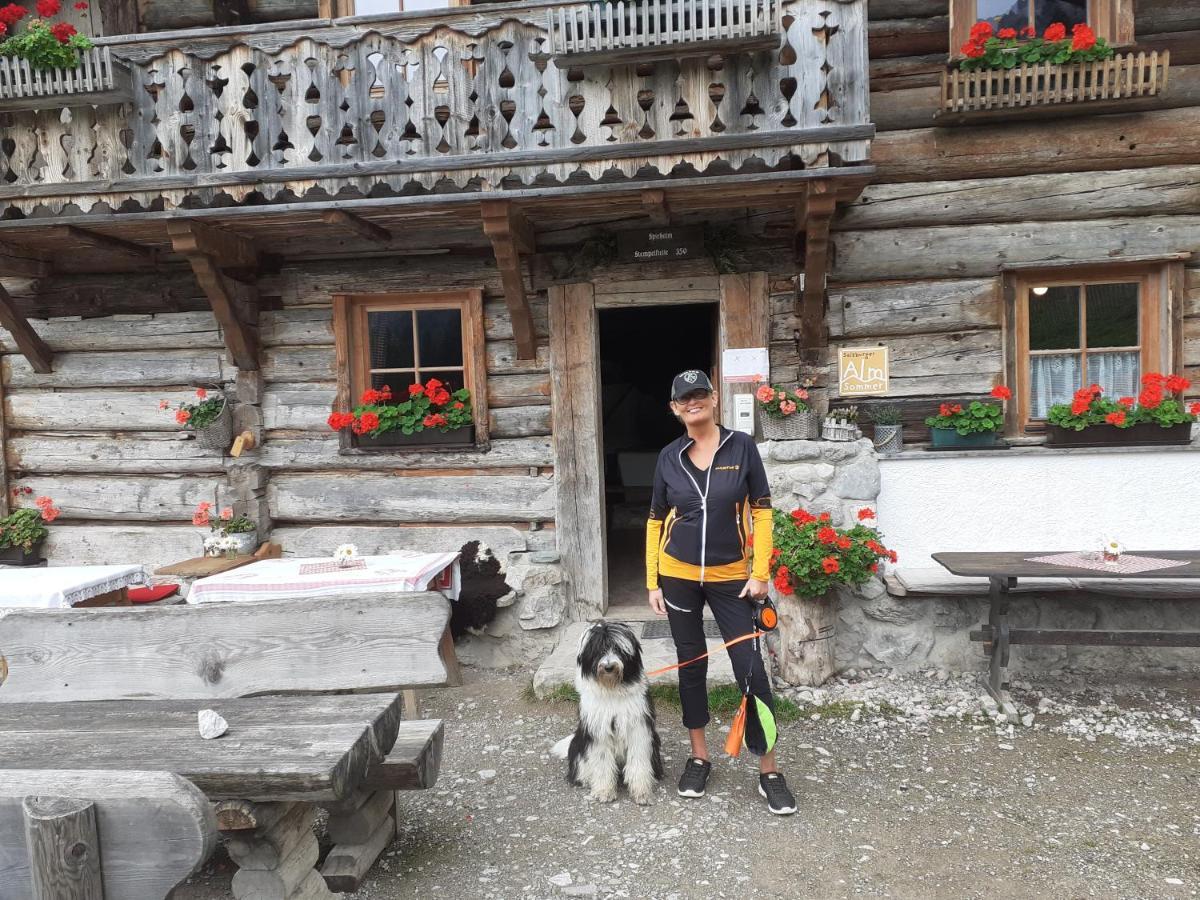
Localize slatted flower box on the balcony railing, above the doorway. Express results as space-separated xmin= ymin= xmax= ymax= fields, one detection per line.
xmin=547 ymin=0 xmax=781 ymax=65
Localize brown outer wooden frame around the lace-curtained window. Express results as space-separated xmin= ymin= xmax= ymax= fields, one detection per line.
xmin=1003 ymin=262 xmax=1183 ymax=437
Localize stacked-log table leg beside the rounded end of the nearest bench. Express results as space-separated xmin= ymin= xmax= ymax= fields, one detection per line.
xmin=224 ymin=803 xmax=334 ymax=900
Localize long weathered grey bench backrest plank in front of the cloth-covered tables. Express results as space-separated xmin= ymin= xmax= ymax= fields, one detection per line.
xmin=0 ymin=593 xmax=449 ymax=705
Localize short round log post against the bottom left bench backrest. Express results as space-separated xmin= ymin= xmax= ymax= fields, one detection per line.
xmin=23 ymin=797 xmax=104 ymax=900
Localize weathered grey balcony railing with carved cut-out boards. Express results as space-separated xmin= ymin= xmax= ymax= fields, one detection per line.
xmin=0 ymin=0 xmax=871 ymax=215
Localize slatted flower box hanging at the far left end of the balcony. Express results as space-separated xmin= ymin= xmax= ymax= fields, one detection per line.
xmin=0 ymin=47 xmax=132 ymax=112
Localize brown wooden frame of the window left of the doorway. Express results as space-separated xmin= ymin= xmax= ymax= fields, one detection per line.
xmin=334 ymin=289 xmax=490 ymax=454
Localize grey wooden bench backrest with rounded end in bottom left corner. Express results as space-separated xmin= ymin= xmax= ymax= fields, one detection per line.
xmin=0 ymin=769 xmax=217 ymax=900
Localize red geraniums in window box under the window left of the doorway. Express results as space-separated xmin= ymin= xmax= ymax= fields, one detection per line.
xmin=328 ymin=378 xmax=475 ymax=448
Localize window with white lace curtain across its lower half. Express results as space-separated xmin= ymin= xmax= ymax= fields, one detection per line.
xmin=1008 ymin=266 xmax=1174 ymax=431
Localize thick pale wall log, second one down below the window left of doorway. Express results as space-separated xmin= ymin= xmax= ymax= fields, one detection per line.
xmin=267 ymin=473 xmax=554 ymax=523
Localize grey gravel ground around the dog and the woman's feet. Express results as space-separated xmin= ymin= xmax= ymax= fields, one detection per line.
xmin=176 ymin=671 xmax=1200 ymax=900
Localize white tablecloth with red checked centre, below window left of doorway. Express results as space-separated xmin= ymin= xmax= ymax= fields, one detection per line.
xmin=187 ymin=552 xmax=460 ymax=604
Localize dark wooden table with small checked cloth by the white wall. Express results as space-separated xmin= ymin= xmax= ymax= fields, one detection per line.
xmin=932 ymin=551 xmax=1200 ymax=715
